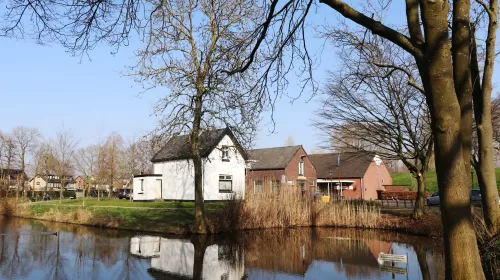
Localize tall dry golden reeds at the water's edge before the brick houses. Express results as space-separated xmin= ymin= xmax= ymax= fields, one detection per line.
xmin=214 ymin=191 xmax=382 ymax=231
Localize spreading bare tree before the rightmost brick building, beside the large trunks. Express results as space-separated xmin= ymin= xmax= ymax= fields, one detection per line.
xmin=316 ymin=32 xmax=433 ymax=218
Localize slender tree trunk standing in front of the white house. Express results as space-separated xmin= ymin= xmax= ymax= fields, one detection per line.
xmin=190 ymin=90 xmax=207 ymax=234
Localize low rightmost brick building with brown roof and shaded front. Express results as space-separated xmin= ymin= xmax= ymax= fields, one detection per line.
xmin=309 ymin=153 xmax=392 ymax=200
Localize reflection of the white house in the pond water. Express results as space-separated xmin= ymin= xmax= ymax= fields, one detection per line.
xmin=130 ymin=236 xmax=245 ymax=280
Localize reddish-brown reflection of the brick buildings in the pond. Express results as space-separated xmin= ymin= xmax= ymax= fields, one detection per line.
xmin=245 ymin=237 xmax=392 ymax=279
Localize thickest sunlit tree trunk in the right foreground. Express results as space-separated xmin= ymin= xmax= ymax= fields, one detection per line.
xmin=420 ymin=0 xmax=484 ymax=279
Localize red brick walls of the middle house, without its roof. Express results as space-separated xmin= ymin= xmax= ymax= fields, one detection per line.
xmin=247 ymin=148 xmax=316 ymax=193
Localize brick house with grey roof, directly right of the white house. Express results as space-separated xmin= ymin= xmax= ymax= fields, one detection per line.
xmin=247 ymin=145 xmax=316 ymax=194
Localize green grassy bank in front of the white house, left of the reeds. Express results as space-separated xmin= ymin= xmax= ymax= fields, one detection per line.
xmin=22 ymin=199 xmax=223 ymax=233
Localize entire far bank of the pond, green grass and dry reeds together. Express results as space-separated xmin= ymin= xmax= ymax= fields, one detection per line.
xmin=0 ymin=195 xmax=440 ymax=235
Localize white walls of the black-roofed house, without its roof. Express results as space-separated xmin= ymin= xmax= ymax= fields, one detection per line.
xmin=152 ymin=135 xmax=245 ymax=200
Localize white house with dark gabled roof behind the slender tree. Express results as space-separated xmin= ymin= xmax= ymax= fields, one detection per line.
xmin=133 ymin=128 xmax=247 ymax=201
